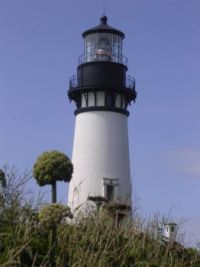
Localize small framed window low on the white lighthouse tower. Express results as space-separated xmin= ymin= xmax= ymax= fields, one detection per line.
xmin=102 ymin=178 xmax=119 ymax=201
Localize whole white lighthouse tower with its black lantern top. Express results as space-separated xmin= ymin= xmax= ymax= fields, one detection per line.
xmin=68 ymin=16 xmax=136 ymax=214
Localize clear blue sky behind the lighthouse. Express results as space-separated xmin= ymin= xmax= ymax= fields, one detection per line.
xmin=0 ymin=0 xmax=200 ymax=247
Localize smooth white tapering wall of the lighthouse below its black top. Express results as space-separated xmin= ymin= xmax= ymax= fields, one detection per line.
xmin=68 ymin=111 xmax=131 ymax=210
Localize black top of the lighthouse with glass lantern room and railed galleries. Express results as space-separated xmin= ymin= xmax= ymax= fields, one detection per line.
xmin=68 ymin=16 xmax=136 ymax=115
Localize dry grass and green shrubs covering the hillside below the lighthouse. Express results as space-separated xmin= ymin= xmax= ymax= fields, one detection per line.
xmin=0 ymin=169 xmax=200 ymax=267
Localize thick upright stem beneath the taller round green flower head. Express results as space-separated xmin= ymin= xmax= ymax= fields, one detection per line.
xmin=50 ymin=181 xmax=57 ymax=267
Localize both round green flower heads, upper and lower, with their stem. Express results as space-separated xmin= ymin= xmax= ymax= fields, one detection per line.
xmin=33 ymin=150 xmax=73 ymax=267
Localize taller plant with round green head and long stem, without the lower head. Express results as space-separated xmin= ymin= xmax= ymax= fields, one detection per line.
xmin=33 ymin=150 xmax=73 ymax=267
